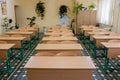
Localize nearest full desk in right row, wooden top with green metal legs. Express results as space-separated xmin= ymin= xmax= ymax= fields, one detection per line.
xmin=101 ymin=42 xmax=120 ymax=72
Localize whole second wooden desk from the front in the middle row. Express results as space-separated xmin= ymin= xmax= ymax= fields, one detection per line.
xmin=35 ymin=44 xmax=83 ymax=55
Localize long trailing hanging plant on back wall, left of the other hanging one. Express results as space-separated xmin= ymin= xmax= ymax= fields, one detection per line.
xmin=35 ymin=1 xmax=45 ymax=20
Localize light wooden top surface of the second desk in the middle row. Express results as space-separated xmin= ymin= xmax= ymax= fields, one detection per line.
xmin=35 ymin=44 xmax=83 ymax=50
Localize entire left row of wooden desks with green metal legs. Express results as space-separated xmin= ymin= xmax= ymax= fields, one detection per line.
xmin=0 ymin=27 xmax=39 ymax=76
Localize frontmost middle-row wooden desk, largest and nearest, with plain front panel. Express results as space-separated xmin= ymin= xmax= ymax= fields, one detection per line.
xmin=25 ymin=56 xmax=96 ymax=80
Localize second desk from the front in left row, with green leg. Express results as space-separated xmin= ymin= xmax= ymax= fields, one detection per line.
xmin=0 ymin=37 xmax=25 ymax=59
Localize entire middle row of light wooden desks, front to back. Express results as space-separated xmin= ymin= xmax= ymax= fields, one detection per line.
xmin=25 ymin=27 xmax=95 ymax=80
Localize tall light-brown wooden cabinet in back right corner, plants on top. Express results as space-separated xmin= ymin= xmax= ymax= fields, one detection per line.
xmin=76 ymin=10 xmax=97 ymax=34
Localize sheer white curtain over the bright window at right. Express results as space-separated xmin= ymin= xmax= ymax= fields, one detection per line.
xmin=98 ymin=0 xmax=114 ymax=25
